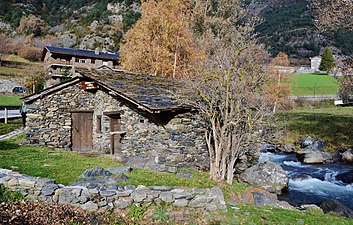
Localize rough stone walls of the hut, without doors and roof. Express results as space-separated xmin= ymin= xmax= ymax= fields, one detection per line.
xmin=26 ymin=83 xmax=209 ymax=172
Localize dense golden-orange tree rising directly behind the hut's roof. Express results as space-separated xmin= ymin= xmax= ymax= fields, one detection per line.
xmin=120 ymin=0 xmax=202 ymax=78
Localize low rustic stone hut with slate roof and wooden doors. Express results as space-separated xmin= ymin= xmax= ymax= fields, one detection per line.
xmin=23 ymin=70 xmax=209 ymax=171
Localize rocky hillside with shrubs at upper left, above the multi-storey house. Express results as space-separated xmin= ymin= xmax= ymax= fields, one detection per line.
xmin=0 ymin=0 xmax=140 ymax=50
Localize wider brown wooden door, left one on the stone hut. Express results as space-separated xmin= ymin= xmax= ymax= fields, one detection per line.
xmin=71 ymin=112 xmax=93 ymax=152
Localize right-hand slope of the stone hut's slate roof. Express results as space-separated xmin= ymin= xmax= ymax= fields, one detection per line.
xmin=79 ymin=70 xmax=188 ymax=112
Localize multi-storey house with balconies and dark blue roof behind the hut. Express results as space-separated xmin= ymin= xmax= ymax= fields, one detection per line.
xmin=42 ymin=46 xmax=120 ymax=86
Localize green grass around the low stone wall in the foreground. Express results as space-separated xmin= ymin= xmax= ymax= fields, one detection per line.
xmin=0 ymin=137 xmax=352 ymax=224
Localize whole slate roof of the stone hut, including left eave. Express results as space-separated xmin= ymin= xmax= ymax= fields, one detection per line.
xmin=22 ymin=70 xmax=190 ymax=113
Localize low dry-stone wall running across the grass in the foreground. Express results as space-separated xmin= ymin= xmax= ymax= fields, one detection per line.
xmin=0 ymin=169 xmax=226 ymax=211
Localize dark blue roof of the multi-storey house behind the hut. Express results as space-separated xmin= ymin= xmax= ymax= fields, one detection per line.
xmin=42 ymin=46 xmax=120 ymax=60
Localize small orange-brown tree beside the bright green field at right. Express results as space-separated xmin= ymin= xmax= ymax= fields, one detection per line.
xmin=267 ymin=52 xmax=290 ymax=112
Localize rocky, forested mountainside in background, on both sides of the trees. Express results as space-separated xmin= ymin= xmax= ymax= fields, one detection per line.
xmin=0 ymin=0 xmax=353 ymax=58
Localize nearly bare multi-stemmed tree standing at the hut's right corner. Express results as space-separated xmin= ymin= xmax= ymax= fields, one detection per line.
xmin=181 ymin=0 xmax=272 ymax=184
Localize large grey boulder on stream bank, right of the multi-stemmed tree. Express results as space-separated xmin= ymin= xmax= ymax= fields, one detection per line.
xmin=240 ymin=162 xmax=288 ymax=194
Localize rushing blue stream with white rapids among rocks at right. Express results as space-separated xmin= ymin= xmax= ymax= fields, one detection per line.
xmin=259 ymin=152 xmax=353 ymax=209
